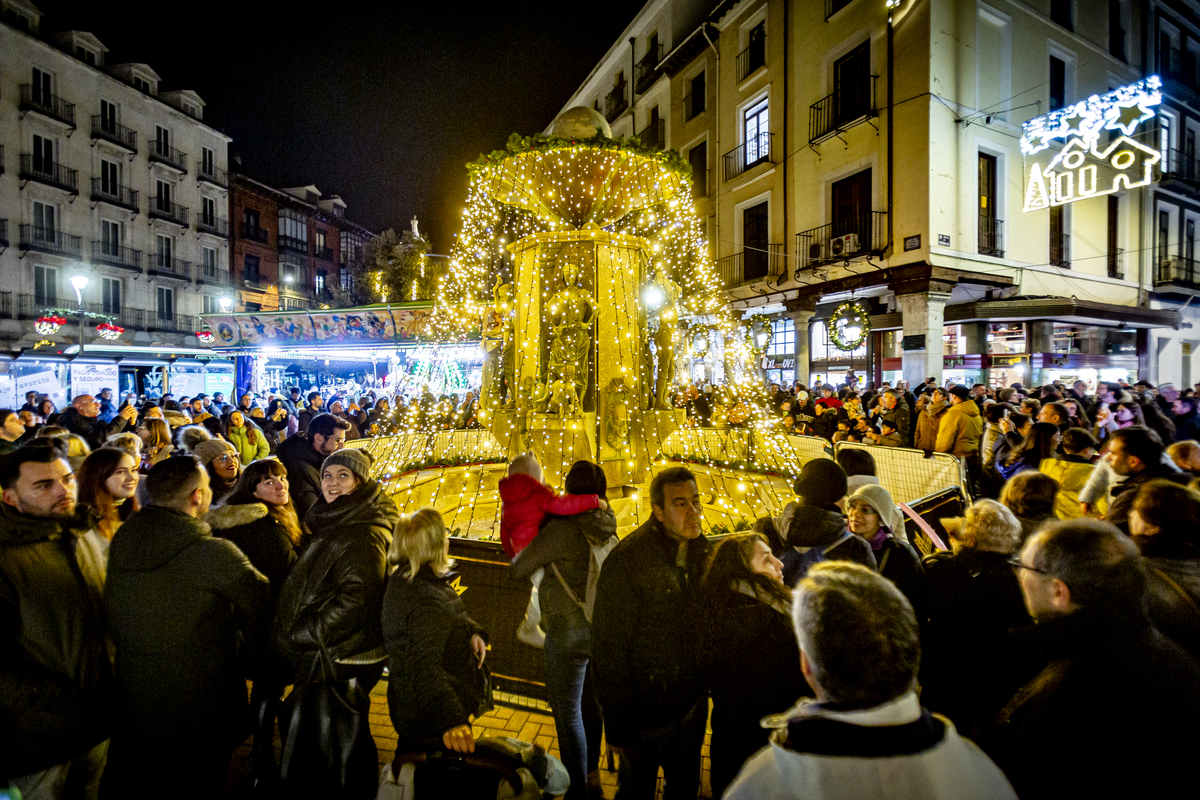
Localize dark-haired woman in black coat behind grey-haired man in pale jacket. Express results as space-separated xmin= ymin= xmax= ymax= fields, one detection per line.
xmin=697 ymin=534 xmax=811 ymax=798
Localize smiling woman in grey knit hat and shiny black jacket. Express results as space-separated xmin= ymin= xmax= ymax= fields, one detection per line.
xmin=274 ymin=450 xmax=400 ymax=798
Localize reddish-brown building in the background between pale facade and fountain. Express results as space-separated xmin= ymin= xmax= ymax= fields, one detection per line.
xmin=226 ymin=170 xmax=374 ymax=311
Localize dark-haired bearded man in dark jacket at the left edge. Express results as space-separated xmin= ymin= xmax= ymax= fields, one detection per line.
xmin=0 ymin=440 xmax=113 ymax=796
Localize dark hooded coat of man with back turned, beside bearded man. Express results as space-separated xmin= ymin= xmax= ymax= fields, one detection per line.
xmin=104 ymin=506 xmax=269 ymax=752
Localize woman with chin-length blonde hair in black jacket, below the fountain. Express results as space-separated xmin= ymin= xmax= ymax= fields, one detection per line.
xmin=383 ymin=509 xmax=490 ymax=753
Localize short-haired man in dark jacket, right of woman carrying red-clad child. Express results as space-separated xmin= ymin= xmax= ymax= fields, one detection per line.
xmin=592 ymin=467 xmax=708 ymax=800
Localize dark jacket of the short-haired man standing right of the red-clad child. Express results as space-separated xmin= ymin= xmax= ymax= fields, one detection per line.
xmin=592 ymin=518 xmax=709 ymax=746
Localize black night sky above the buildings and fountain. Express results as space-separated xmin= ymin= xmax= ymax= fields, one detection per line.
xmin=34 ymin=0 xmax=644 ymax=253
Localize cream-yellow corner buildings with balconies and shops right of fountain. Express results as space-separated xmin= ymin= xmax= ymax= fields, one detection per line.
xmin=554 ymin=0 xmax=1200 ymax=385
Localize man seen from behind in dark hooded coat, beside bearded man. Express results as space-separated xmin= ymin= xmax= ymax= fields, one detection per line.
xmin=103 ymin=456 xmax=270 ymax=798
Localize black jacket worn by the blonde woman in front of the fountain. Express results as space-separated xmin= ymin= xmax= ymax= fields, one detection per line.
xmin=383 ymin=564 xmax=487 ymax=752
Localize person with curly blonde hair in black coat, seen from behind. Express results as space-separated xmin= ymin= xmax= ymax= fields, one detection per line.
xmin=920 ymin=496 xmax=1027 ymax=736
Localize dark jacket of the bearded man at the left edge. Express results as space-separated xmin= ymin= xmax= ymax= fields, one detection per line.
xmin=0 ymin=503 xmax=113 ymax=777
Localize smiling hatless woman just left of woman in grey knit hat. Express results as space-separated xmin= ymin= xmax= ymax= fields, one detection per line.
xmin=204 ymin=458 xmax=302 ymax=786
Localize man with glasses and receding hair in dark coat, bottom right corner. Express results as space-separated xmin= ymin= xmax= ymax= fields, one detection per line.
xmin=991 ymin=520 xmax=1200 ymax=800
